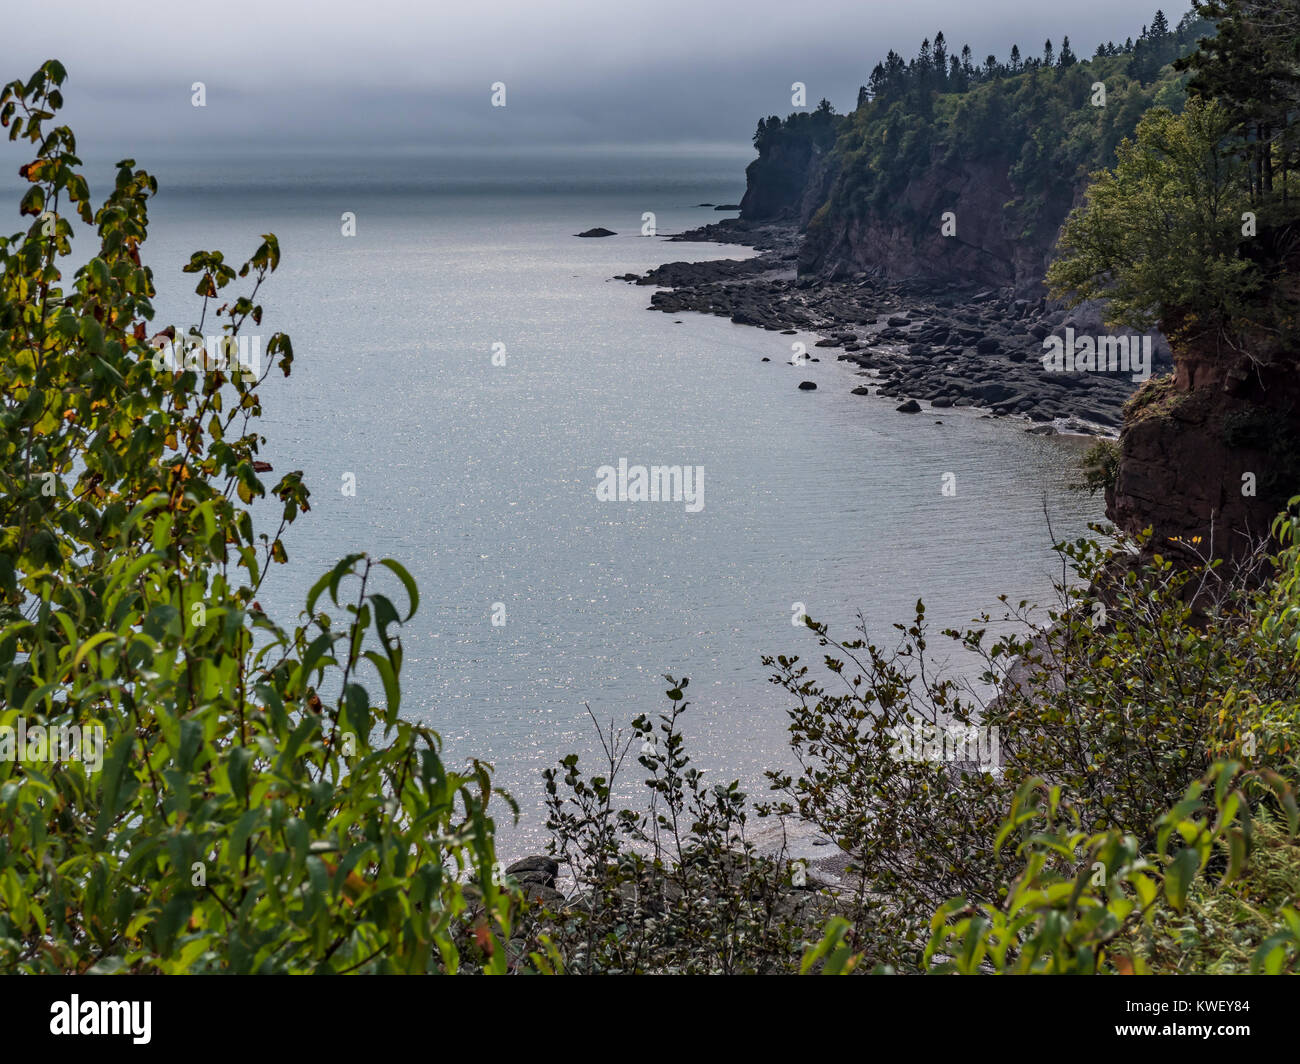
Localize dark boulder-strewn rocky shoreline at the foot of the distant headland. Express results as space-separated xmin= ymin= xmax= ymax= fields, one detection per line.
xmin=618 ymin=219 xmax=1171 ymax=436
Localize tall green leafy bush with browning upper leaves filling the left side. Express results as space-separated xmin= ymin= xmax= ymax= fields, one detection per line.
xmin=0 ymin=61 xmax=511 ymax=973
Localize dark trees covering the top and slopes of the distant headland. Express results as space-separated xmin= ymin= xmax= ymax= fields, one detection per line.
xmin=742 ymin=10 xmax=1213 ymax=278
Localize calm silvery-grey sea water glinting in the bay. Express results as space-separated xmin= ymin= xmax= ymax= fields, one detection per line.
xmin=4 ymin=150 xmax=1100 ymax=853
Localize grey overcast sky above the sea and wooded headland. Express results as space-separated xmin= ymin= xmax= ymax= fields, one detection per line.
xmin=0 ymin=0 xmax=1190 ymax=153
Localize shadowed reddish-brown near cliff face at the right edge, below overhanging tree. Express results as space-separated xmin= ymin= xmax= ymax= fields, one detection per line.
xmin=1106 ymin=327 xmax=1300 ymax=558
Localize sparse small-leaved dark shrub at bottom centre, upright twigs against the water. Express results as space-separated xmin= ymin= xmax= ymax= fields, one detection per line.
xmin=534 ymin=676 xmax=828 ymax=974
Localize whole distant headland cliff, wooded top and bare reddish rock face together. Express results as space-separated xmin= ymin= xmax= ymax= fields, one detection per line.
xmin=741 ymin=52 xmax=1190 ymax=302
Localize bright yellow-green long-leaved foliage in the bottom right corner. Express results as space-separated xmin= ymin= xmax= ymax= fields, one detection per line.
xmin=926 ymin=762 xmax=1300 ymax=976
